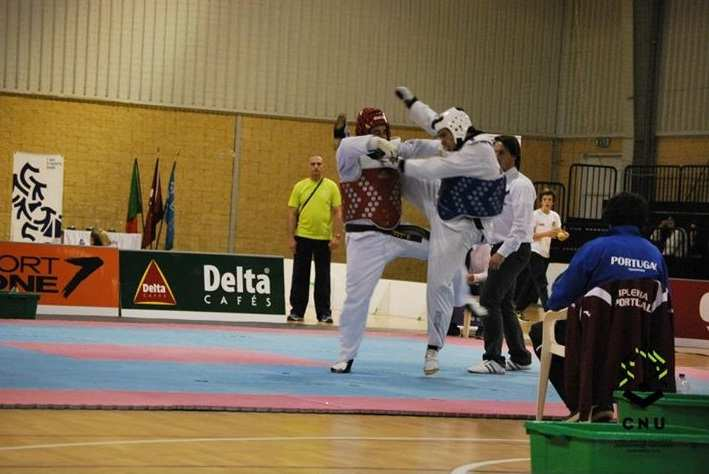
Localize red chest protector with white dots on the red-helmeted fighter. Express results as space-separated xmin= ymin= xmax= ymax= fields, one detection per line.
xmin=340 ymin=168 xmax=401 ymax=229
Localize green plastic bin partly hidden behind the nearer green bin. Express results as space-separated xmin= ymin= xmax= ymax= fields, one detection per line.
xmin=613 ymin=391 xmax=709 ymax=432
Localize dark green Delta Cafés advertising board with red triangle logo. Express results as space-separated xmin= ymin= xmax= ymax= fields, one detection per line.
xmin=120 ymin=251 xmax=285 ymax=322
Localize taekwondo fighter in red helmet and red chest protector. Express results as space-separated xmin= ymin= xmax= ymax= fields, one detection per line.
xmin=330 ymin=107 xmax=439 ymax=373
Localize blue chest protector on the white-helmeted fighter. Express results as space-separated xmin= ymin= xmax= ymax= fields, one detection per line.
xmin=438 ymin=176 xmax=507 ymax=221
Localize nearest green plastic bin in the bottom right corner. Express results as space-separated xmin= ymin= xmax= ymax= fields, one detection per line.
xmin=525 ymin=421 xmax=709 ymax=474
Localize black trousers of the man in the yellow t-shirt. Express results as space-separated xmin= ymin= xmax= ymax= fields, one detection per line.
xmin=290 ymin=236 xmax=330 ymax=319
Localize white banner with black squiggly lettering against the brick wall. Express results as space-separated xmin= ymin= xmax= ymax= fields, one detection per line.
xmin=10 ymin=152 xmax=64 ymax=243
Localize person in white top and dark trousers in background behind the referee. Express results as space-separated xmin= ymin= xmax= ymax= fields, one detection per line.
xmin=515 ymin=189 xmax=569 ymax=312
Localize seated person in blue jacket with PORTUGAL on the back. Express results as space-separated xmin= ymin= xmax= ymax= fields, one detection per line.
xmin=529 ymin=192 xmax=667 ymax=421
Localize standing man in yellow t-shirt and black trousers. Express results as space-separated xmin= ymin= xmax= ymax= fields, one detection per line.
xmin=288 ymin=155 xmax=342 ymax=324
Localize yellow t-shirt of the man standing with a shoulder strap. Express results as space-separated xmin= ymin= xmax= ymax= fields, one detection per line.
xmin=288 ymin=178 xmax=342 ymax=240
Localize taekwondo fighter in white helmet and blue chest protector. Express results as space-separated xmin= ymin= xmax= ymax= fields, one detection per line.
xmin=396 ymin=87 xmax=505 ymax=373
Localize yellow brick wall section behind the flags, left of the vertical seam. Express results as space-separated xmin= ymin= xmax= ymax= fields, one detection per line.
xmin=0 ymin=95 xmax=235 ymax=251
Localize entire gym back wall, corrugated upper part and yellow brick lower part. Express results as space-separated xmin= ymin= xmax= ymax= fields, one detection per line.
xmin=0 ymin=0 xmax=709 ymax=278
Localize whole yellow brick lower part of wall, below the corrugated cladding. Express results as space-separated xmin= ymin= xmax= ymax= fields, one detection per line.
xmin=0 ymin=91 xmax=549 ymax=281
